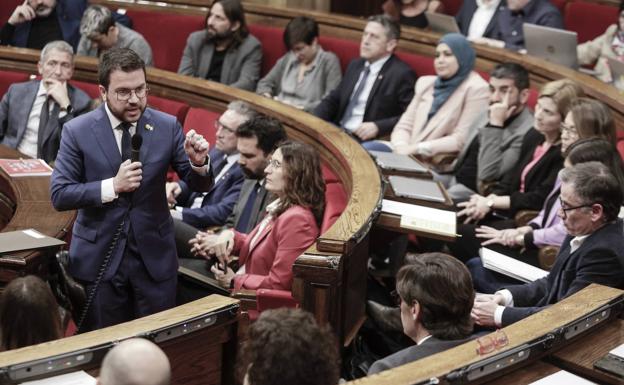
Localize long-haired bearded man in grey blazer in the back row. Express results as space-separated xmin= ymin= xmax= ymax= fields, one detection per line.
xmin=178 ymin=0 xmax=262 ymax=92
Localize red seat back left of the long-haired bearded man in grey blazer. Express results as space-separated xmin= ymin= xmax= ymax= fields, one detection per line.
xmin=126 ymin=10 xmax=205 ymax=72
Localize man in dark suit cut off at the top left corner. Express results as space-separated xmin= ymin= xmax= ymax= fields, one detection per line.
xmin=0 ymin=0 xmax=87 ymax=49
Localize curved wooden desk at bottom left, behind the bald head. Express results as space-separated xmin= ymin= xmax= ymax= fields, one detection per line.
xmin=0 ymin=295 xmax=244 ymax=385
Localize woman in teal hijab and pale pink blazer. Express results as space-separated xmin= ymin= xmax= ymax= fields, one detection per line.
xmin=364 ymin=33 xmax=489 ymax=157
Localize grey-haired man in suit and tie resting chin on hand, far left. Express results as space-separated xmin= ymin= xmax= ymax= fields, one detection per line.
xmin=0 ymin=40 xmax=91 ymax=163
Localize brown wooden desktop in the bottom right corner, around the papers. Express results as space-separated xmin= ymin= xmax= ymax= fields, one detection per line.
xmin=550 ymin=319 xmax=624 ymax=385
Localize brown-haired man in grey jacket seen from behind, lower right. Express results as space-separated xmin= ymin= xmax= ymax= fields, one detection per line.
xmin=368 ymin=253 xmax=475 ymax=375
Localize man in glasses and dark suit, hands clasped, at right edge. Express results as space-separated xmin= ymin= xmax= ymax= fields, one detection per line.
xmin=472 ymin=162 xmax=624 ymax=327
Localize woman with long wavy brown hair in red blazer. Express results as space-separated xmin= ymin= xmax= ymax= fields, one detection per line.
xmin=200 ymin=142 xmax=325 ymax=290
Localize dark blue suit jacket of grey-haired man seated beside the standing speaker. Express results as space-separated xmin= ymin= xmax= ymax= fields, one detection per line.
xmin=178 ymin=149 xmax=245 ymax=229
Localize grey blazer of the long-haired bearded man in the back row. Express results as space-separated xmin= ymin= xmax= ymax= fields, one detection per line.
xmin=178 ymin=30 xmax=262 ymax=91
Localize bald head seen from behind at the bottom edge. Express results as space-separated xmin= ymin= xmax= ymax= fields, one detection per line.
xmin=98 ymin=338 xmax=171 ymax=385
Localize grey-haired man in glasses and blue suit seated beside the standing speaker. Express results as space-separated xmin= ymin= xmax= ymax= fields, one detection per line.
xmin=166 ymin=101 xmax=256 ymax=258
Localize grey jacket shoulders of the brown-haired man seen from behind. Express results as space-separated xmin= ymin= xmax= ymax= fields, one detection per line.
xmin=368 ymin=336 xmax=475 ymax=376
